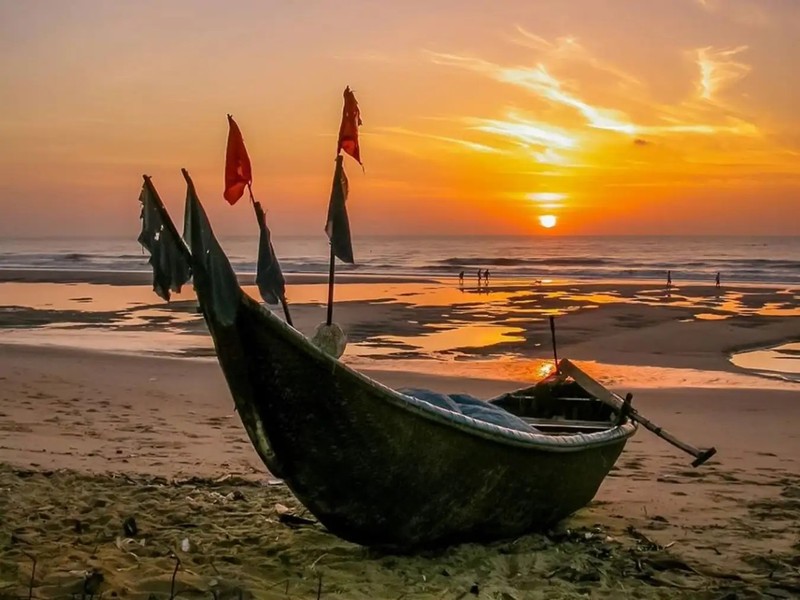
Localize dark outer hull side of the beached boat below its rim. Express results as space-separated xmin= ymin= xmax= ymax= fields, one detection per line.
xmin=212 ymin=296 xmax=634 ymax=548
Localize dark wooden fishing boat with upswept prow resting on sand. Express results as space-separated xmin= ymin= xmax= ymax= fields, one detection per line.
xmin=175 ymin=176 xmax=637 ymax=551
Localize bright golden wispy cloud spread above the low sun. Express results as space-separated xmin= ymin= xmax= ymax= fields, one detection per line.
xmin=416 ymin=27 xmax=791 ymax=203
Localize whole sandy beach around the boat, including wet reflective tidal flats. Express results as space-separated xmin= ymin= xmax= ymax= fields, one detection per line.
xmin=0 ymin=273 xmax=800 ymax=600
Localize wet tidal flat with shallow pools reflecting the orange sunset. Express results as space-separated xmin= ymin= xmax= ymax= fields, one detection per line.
xmin=0 ymin=274 xmax=800 ymax=389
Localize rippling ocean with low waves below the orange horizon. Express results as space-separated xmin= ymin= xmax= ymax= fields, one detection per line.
xmin=0 ymin=235 xmax=800 ymax=284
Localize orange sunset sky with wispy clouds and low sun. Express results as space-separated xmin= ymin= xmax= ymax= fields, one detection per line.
xmin=0 ymin=0 xmax=800 ymax=237
